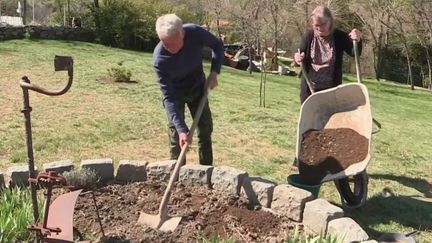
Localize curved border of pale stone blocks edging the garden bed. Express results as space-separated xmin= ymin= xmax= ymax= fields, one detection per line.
xmin=0 ymin=158 xmax=376 ymax=243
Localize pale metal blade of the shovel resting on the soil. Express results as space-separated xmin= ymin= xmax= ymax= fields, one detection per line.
xmin=137 ymin=212 xmax=182 ymax=232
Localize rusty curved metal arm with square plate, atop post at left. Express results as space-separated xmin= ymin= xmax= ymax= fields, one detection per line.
xmin=20 ymin=56 xmax=73 ymax=96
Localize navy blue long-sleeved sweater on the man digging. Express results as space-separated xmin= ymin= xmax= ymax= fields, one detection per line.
xmin=153 ymin=24 xmax=224 ymax=133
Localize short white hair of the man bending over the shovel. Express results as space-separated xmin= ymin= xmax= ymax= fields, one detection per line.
xmin=156 ymin=14 xmax=183 ymax=38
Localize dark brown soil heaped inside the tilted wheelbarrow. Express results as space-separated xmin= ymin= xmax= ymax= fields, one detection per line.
xmin=299 ymin=128 xmax=369 ymax=184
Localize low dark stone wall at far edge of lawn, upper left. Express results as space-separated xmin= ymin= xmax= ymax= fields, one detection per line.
xmin=0 ymin=25 xmax=95 ymax=42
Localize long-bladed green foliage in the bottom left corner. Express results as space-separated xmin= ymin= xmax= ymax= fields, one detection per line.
xmin=0 ymin=188 xmax=44 ymax=242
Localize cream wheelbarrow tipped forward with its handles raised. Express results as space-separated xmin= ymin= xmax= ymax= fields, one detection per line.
xmin=288 ymin=41 xmax=373 ymax=207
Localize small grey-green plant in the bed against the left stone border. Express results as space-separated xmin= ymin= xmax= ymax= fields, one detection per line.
xmin=63 ymin=168 xmax=99 ymax=190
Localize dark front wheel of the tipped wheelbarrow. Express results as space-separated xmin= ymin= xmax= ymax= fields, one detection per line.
xmin=335 ymin=171 xmax=368 ymax=208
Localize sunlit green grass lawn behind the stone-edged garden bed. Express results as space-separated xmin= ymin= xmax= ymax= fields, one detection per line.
xmin=0 ymin=40 xmax=432 ymax=242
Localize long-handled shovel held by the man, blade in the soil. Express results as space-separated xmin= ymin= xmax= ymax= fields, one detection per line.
xmin=137 ymin=89 xmax=208 ymax=232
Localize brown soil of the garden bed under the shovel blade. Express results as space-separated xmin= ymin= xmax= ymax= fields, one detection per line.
xmin=74 ymin=182 xmax=293 ymax=242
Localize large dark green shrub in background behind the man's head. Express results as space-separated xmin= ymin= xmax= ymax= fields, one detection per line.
xmin=90 ymin=0 xmax=202 ymax=50
